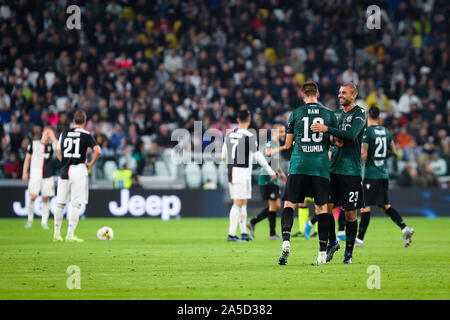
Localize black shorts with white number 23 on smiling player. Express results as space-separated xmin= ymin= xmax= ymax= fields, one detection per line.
xmin=330 ymin=173 xmax=364 ymax=211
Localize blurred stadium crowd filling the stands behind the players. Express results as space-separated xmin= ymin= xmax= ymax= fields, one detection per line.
xmin=0 ymin=0 xmax=450 ymax=187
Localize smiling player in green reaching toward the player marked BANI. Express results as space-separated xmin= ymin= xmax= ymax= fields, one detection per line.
xmin=311 ymin=83 xmax=366 ymax=264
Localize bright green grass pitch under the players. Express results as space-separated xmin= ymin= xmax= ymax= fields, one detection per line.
xmin=0 ymin=218 xmax=450 ymax=300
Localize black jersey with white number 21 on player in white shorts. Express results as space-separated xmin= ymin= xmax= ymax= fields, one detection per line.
xmin=58 ymin=128 xmax=97 ymax=179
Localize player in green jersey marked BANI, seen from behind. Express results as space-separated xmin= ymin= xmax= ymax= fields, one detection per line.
xmin=278 ymin=81 xmax=337 ymax=265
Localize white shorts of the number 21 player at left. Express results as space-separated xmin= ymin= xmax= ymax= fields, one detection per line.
xmin=56 ymin=163 xmax=89 ymax=205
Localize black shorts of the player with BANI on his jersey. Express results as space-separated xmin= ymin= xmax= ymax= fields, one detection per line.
xmin=283 ymin=174 xmax=330 ymax=206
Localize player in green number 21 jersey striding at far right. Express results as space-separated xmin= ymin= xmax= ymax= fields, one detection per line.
xmin=355 ymin=106 xmax=414 ymax=247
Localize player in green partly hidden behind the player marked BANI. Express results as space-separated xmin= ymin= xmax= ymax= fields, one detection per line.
xmin=247 ymin=123 xmax=286 ymax=240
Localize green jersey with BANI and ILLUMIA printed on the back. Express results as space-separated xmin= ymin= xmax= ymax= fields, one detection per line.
xmin=287 ymin=103 xmax=337 ymax=179
